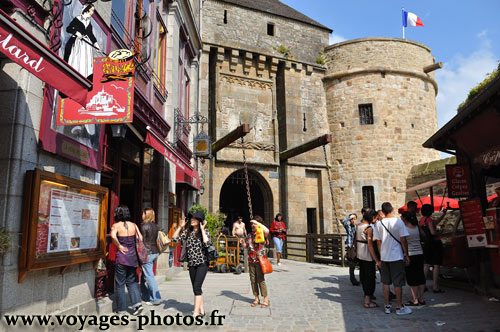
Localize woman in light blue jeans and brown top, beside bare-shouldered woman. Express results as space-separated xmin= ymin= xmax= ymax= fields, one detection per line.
xmin=141 ymin=208 xmax=161 ymax=305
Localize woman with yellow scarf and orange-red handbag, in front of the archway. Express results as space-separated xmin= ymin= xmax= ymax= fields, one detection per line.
xmin=244 ymin=216 xmax=269 ymax=308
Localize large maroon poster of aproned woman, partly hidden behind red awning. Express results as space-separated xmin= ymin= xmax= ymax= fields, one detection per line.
xmin=40 ymin=0 xmax=111 ymax=170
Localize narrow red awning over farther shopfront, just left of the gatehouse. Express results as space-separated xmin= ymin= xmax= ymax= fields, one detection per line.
xmin=146 ymin=133 xmax=200 ymax=190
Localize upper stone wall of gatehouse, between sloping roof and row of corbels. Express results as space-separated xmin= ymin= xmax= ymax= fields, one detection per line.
xmin=202 ymin=0 xmax=329 ymax=63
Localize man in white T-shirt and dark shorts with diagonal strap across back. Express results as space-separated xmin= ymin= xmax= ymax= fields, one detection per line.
xmin=373 ymin=202 xmax=412 ymax=315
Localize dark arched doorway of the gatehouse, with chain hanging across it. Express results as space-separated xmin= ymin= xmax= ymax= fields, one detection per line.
xmin=219 ymin=169 xmax=273 ymax=230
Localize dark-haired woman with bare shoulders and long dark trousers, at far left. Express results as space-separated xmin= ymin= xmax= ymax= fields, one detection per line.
xmin=111 ymin=205 xmax=143 ymax=315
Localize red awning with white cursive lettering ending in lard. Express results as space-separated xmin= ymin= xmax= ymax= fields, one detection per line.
xmin=0 ymin=10 xmax=92 ymax=105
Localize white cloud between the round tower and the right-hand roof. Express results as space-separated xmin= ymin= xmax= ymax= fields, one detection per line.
xmin=436 ymin=31 xmax=498 ymax=127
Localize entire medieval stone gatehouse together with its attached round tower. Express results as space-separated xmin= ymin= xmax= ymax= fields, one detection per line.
xmin=200 ymin=0 xmax=439 ymax=234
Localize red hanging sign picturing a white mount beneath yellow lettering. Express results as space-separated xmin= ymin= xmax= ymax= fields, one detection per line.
xmin=57 ymin=50 xmax=135 ymax=126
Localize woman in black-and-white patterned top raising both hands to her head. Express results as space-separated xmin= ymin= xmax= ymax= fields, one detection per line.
xmin=172 ymin=211 xmax=212 ymax=317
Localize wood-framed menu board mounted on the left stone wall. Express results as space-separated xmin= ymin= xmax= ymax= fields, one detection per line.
xmin=18 ymin=169 xmax=108 ymax=283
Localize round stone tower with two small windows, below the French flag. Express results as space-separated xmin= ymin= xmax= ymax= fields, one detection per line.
xmin=324 ymin=38 xmax=440 ymax=219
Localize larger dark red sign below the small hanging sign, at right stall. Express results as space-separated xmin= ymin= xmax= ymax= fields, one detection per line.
xmin=460 ymin=198 xmax=488 ymax=248
